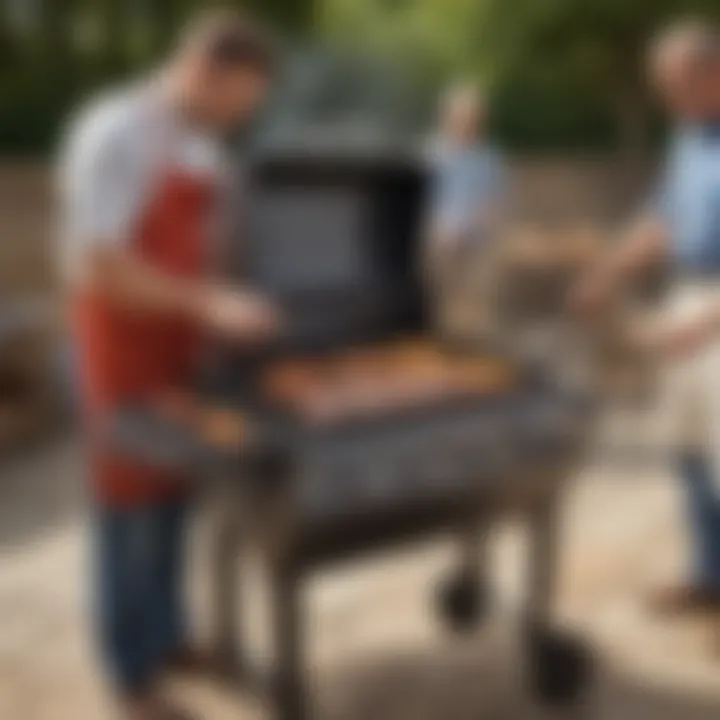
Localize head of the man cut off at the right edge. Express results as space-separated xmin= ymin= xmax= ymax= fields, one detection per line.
xmin=649 ymin=21 xmax=720 ymax=121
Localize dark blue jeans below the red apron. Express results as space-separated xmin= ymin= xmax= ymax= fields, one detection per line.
xmin=95 ymin=500 xmax=187 ymax=693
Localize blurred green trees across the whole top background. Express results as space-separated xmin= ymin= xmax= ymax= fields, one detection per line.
xmin=7 ymin=0 xmax=720 ymax=153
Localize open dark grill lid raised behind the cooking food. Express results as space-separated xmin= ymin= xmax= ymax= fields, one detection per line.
xmin=238 ymin=147 xmax=427 ymax=354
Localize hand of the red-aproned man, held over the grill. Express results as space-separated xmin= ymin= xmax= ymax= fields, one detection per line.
xmin=200 ymin=287 xmax=279 ymax=342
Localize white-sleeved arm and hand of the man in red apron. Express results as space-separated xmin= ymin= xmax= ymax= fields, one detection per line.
xmin=61 ymin=104 xmax=275 ymax=340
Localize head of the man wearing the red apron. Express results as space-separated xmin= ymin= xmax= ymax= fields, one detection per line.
xmin=170 ymin=10 xmax=276 ymax=130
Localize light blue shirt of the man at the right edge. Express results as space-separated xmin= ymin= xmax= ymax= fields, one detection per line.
xmin=656 ymin=124 xmax=720 ymax=275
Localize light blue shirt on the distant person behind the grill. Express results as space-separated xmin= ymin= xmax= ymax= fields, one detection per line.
xmin=431 ymin=145 xmax=505 ymax=238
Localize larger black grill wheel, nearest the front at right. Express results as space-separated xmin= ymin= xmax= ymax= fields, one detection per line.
xmin=527 ymin=628 xmax=594 ymax=706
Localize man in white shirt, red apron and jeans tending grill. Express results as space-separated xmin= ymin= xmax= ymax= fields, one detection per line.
xmin=61 ymin=12 xmax=275 ymax=720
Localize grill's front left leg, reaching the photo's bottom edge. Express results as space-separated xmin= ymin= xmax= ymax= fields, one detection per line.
xmin=272 ymin=564 xmax=309 ymax=720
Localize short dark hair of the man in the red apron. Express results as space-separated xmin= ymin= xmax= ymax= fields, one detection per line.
xmin=180 ymin=9 xmax=278 ymax=75
